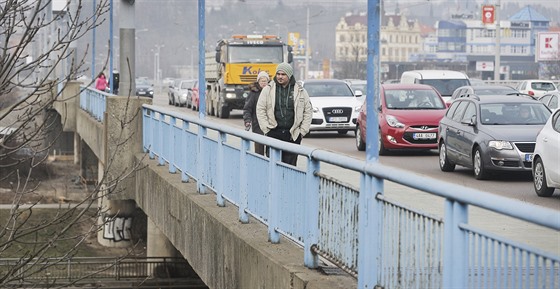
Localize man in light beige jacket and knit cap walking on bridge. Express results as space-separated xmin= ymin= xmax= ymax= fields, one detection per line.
xmin=257 ymin=63 xmax=313 ymax=166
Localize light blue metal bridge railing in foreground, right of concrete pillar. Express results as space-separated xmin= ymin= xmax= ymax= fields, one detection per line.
xmin=143 ymin=105 xmax=560 ymax=288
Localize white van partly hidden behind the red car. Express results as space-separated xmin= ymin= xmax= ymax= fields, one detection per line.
xmin=401 ymin=70 xmax=471 ymax=102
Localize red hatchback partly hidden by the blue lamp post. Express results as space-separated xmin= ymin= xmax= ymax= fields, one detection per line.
xmin=355 ymin=83 xmax=447 ymax=155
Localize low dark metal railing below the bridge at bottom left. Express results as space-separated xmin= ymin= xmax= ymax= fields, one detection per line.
xmin=0 ymin=257 xmax=188 ymax=285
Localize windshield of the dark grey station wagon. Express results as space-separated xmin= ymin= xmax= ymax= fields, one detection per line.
xmin=480 ymin=103 xmax=551 ymax=125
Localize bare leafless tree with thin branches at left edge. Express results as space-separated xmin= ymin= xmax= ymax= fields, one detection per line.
xmin=0 ymin=0 xmax=144 ymax=288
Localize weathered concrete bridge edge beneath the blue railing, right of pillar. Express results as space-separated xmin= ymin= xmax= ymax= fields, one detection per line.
xmin=135 ymin=154 xmax=357 ymax=289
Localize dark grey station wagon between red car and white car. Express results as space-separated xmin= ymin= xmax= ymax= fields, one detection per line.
xmin=439 ymin=95 xmax=551 ymax=180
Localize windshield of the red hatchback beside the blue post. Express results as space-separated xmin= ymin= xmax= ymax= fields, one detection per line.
xmin=385 ymin=89 xmax=446 ymax=110
